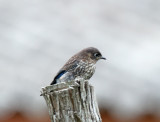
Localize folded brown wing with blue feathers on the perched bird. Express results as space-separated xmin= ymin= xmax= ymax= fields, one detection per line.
xmin=51 ymin=60 xmax=79 ymax=85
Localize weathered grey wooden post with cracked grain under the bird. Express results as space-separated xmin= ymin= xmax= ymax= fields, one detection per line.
xmin=41 ymin=81 xmax=101 ymax=122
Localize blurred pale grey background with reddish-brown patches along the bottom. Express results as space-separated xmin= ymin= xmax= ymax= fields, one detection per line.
xmin=0 ymin=0 xmax=160 ymax=122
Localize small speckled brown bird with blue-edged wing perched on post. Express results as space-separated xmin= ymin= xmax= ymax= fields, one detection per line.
xmin=51 ymin=47 xmax=106 ymax=85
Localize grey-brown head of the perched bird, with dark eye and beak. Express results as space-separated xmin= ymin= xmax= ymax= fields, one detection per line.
xmin=79 ymin=47 xmax=106 ymax=63
